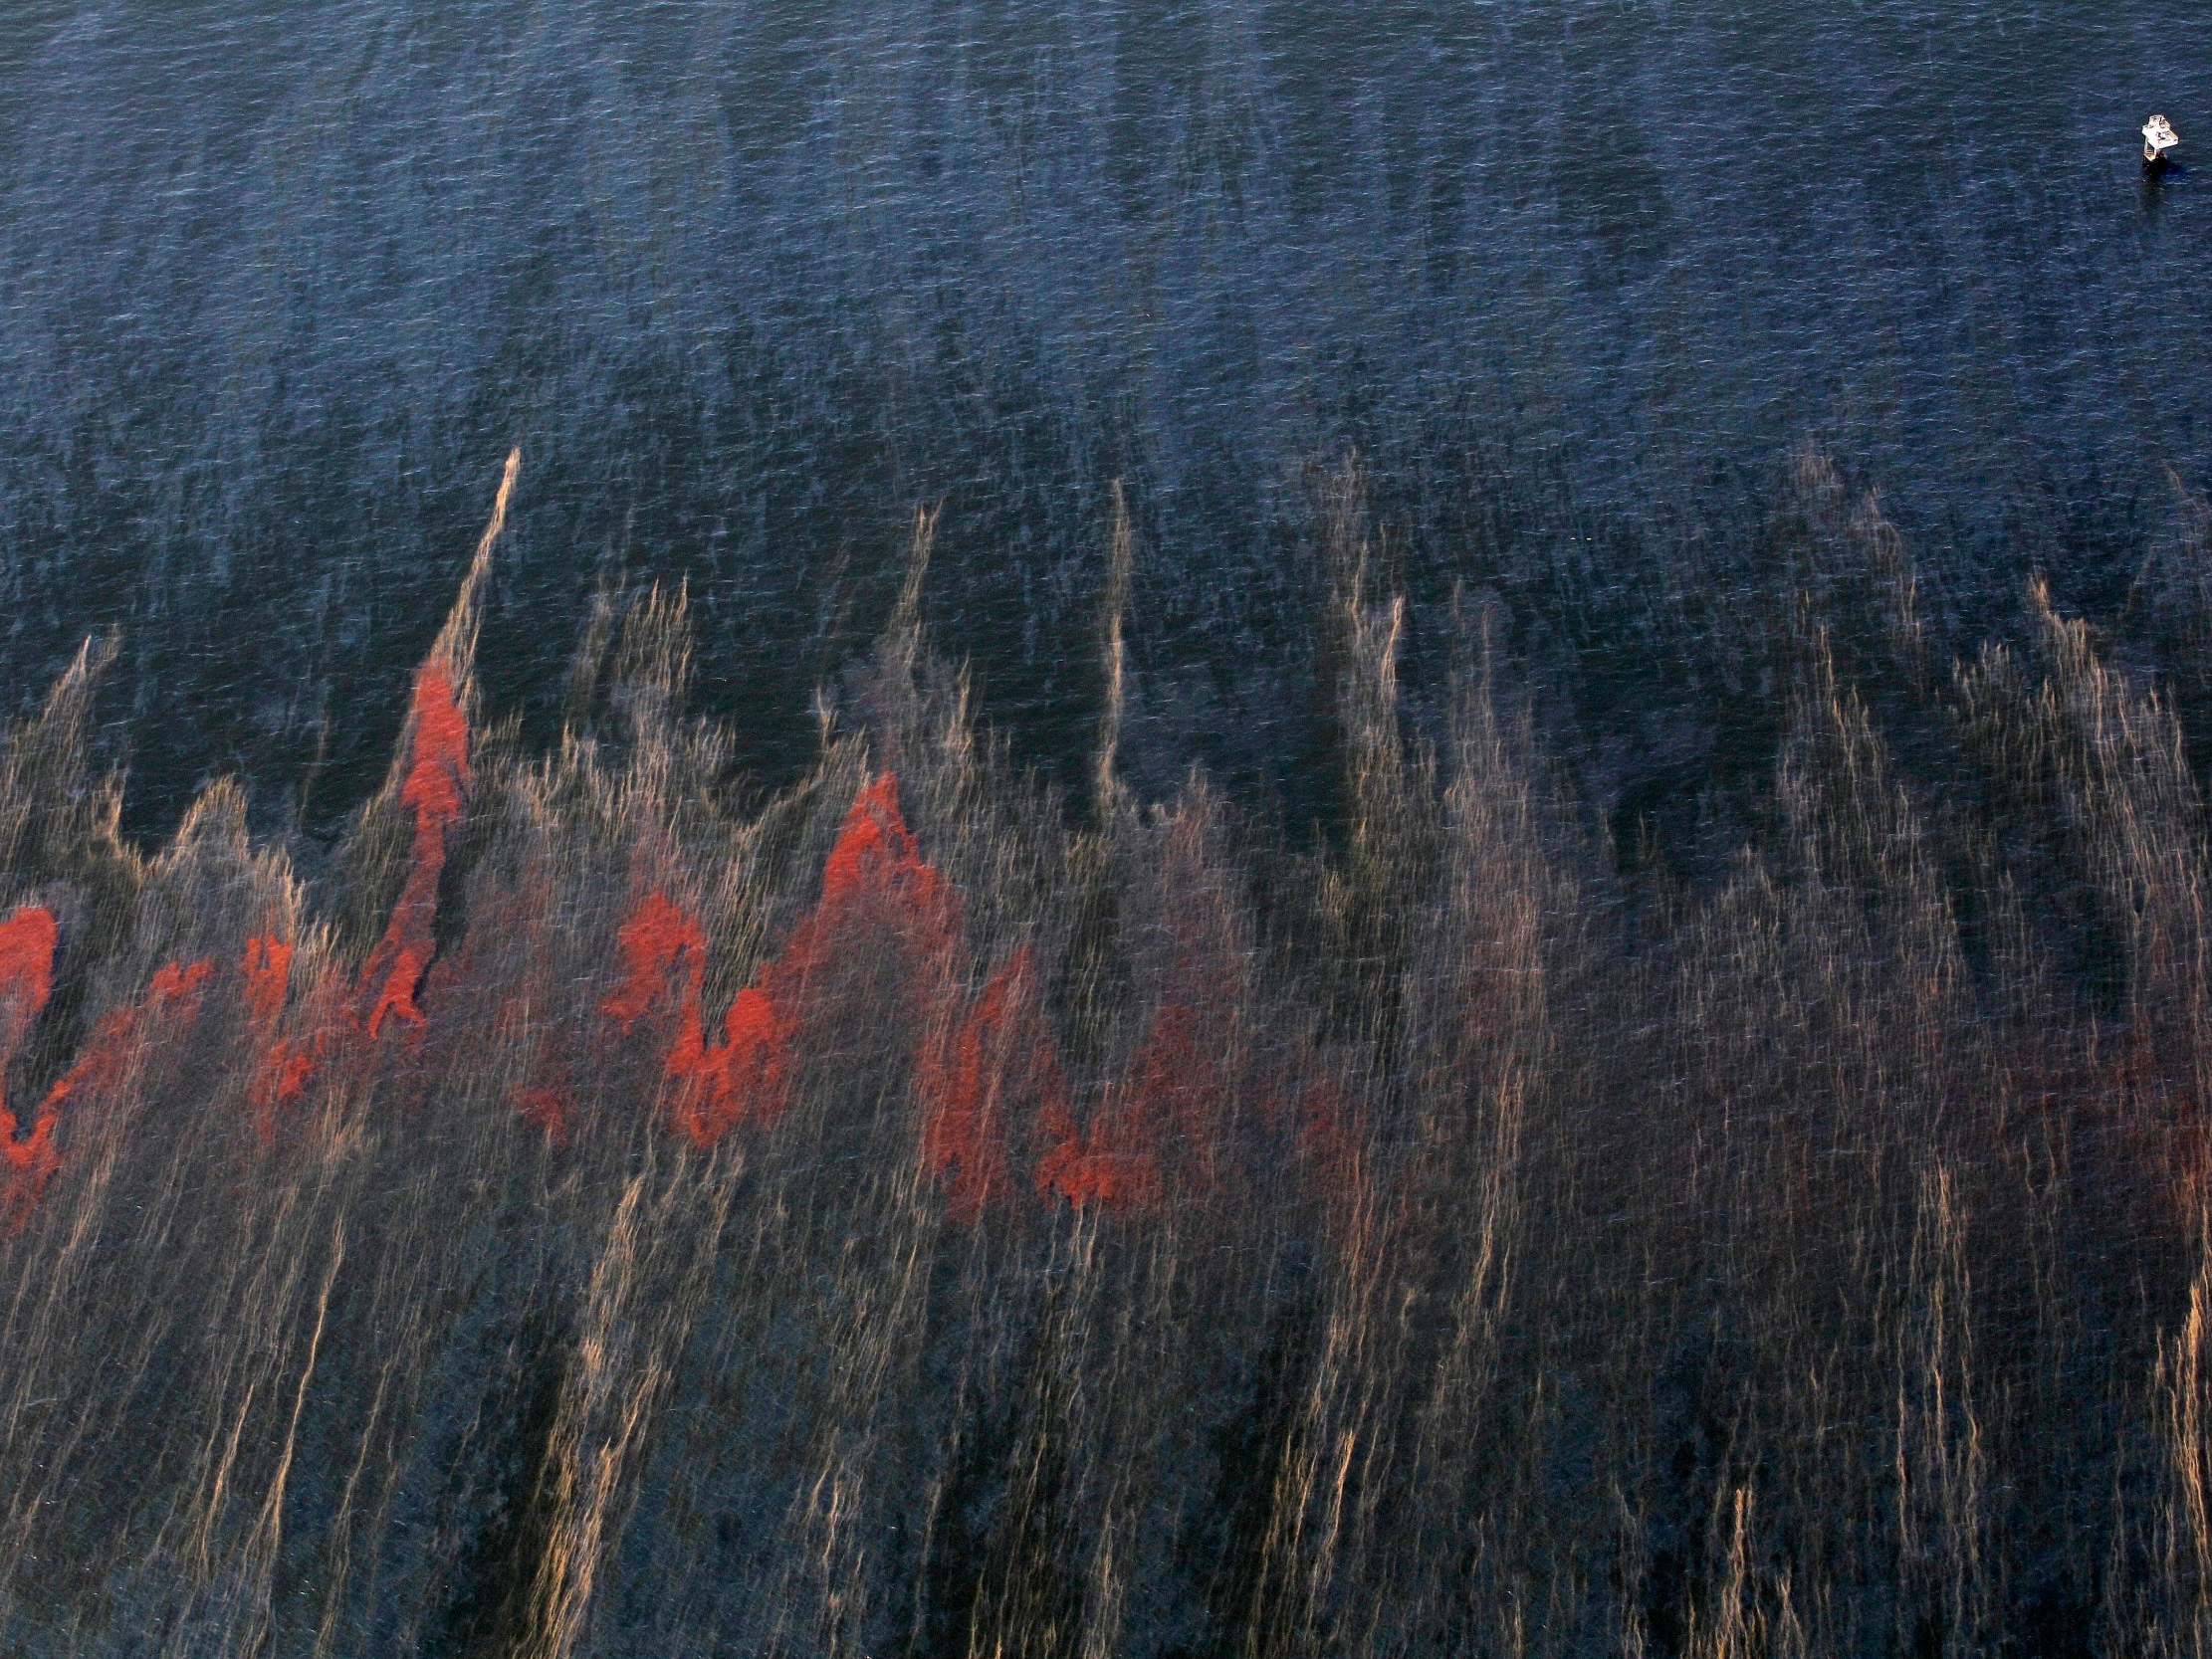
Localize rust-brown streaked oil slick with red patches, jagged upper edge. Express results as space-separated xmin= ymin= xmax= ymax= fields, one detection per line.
xmin=13 ymin=463 xmax=2212 ymax=1657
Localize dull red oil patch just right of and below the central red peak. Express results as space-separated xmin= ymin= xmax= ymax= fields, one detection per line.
xmin=916 ymin=944 xmax=1068 ymax=1221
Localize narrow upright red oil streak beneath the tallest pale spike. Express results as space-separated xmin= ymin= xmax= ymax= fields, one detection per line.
xmin=360 ymin=662 xmax=469 ymax=1042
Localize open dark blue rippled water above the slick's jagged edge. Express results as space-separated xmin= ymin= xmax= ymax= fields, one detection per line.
xmin=0 ymin=0 xmax=2212 ymax=845
